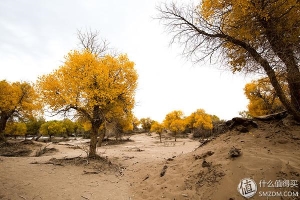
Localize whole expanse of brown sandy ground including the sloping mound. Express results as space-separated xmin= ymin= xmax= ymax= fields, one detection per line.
xmin=0 ymin=120 xmax=300 ymax=200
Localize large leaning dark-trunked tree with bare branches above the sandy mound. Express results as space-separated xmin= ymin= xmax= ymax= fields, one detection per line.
xmin=158 ymin=0 xmax=300 ymax=121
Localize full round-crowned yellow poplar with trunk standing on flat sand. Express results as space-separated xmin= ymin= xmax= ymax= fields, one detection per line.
xmin=37 ymin=49 xmax=138 ymax=157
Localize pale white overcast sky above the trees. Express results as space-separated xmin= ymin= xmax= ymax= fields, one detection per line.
xmin=0 ymin=0 xmax=250 ymax=121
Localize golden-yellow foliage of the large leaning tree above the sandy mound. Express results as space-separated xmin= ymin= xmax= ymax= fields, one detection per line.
xmin=198 ymin=0 xmax=300 ymax=72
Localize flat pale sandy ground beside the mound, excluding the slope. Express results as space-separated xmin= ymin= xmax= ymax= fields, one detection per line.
xmin=0 ymin=134 xmax=199 ymax=199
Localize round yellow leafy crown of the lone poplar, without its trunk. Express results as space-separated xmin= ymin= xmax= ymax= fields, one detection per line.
xmin=38 ymin=51 xmax=137 ymax=110
